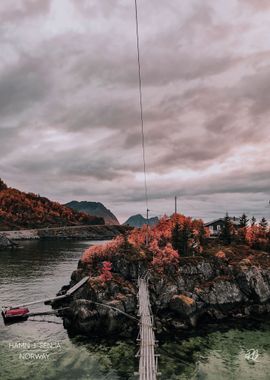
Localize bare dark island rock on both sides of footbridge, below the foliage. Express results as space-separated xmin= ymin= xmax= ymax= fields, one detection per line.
xmin=59 ymin=248 xmax=270 ymax=336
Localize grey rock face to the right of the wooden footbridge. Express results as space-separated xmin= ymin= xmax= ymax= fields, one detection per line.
xmin=150 ymin=258 xmax=270 ymax=331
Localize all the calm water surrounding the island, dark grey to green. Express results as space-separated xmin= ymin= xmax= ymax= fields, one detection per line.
xmin=0 ymin=241 xmax=270 ymax=380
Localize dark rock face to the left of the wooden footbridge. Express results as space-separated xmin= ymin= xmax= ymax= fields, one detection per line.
xmin=59 ymin=260 xmax=142 ymax=337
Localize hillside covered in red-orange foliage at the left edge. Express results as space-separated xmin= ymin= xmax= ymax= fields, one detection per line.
xmin=0 ymin=179 xmax=104 ymax=230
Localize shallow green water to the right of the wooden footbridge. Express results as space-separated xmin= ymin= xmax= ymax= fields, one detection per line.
xmin=160 ymin=323 xmax=270 ymax=380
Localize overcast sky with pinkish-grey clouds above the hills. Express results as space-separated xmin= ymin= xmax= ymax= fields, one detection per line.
xmin=0 ymin=0 xmax=270 ymax=221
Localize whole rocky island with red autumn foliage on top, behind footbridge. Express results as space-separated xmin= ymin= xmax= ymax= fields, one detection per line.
xmin=56 ymin=214 xmax=270 ymax=337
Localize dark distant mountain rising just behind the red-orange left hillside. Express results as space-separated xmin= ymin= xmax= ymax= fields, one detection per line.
xmin=65 ymin=201 xmax=120 ymax=225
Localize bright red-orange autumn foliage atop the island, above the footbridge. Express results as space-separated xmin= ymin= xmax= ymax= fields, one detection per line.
xmin=82 ymin=214 xmax=208 ymax=276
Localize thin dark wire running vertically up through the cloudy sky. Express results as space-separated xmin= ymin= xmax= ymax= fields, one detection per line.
xmin=135 ymin=0 xmax=149 ymax=223
